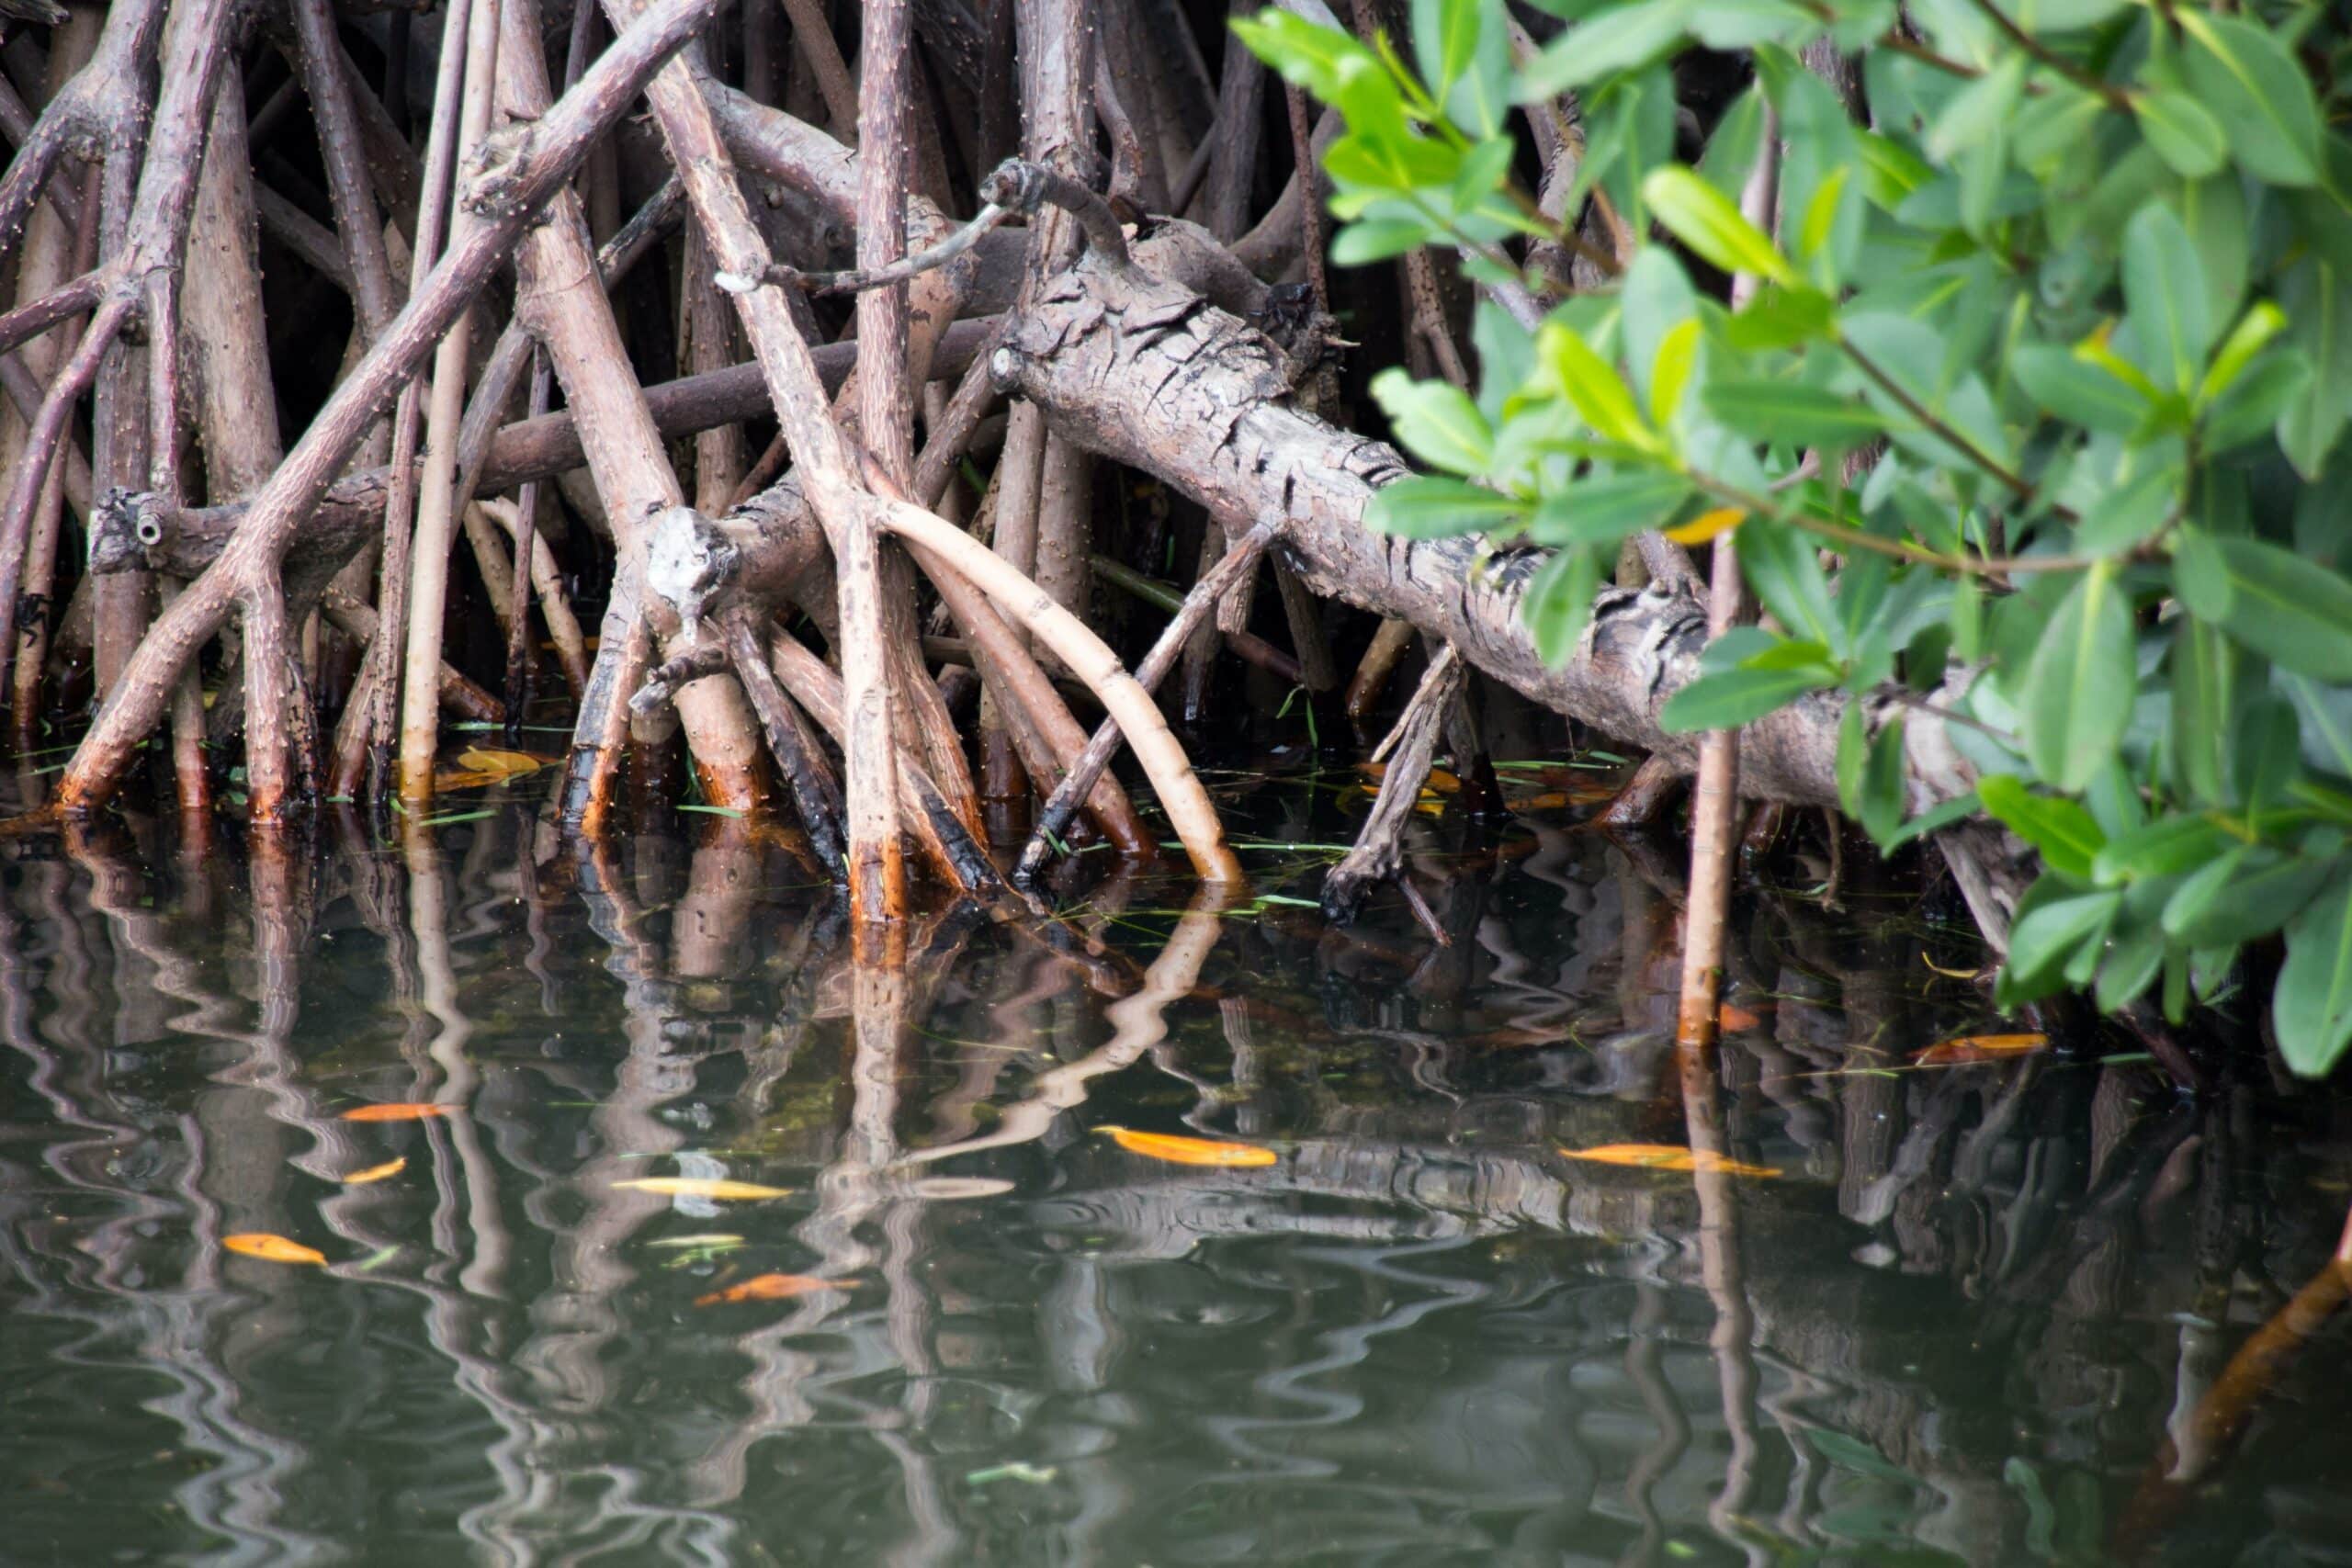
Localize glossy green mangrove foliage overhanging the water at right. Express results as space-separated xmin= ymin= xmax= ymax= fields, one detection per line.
xmin=1235 ymin=0 xmax=2352 ymax=1072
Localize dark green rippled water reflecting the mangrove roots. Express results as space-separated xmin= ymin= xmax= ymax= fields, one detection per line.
xmin=0 ymin=773 xmax=2352 ymax=1565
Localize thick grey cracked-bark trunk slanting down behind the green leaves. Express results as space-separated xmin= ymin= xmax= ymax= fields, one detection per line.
xmin=990 ymin=244 xmax=1973 ymax=811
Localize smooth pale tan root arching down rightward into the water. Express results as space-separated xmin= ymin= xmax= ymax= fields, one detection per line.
xmin=875 ymin=501 xmax=1244 ymax=886
